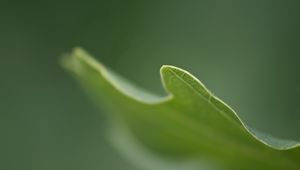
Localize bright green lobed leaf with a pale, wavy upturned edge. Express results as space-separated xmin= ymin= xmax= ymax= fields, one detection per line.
xmin=62 ymin=48 xmax=300 ymax=170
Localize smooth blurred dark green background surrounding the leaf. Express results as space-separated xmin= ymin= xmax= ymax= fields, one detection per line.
xmin=0 ymin=0 xmax=300 ymax=170
